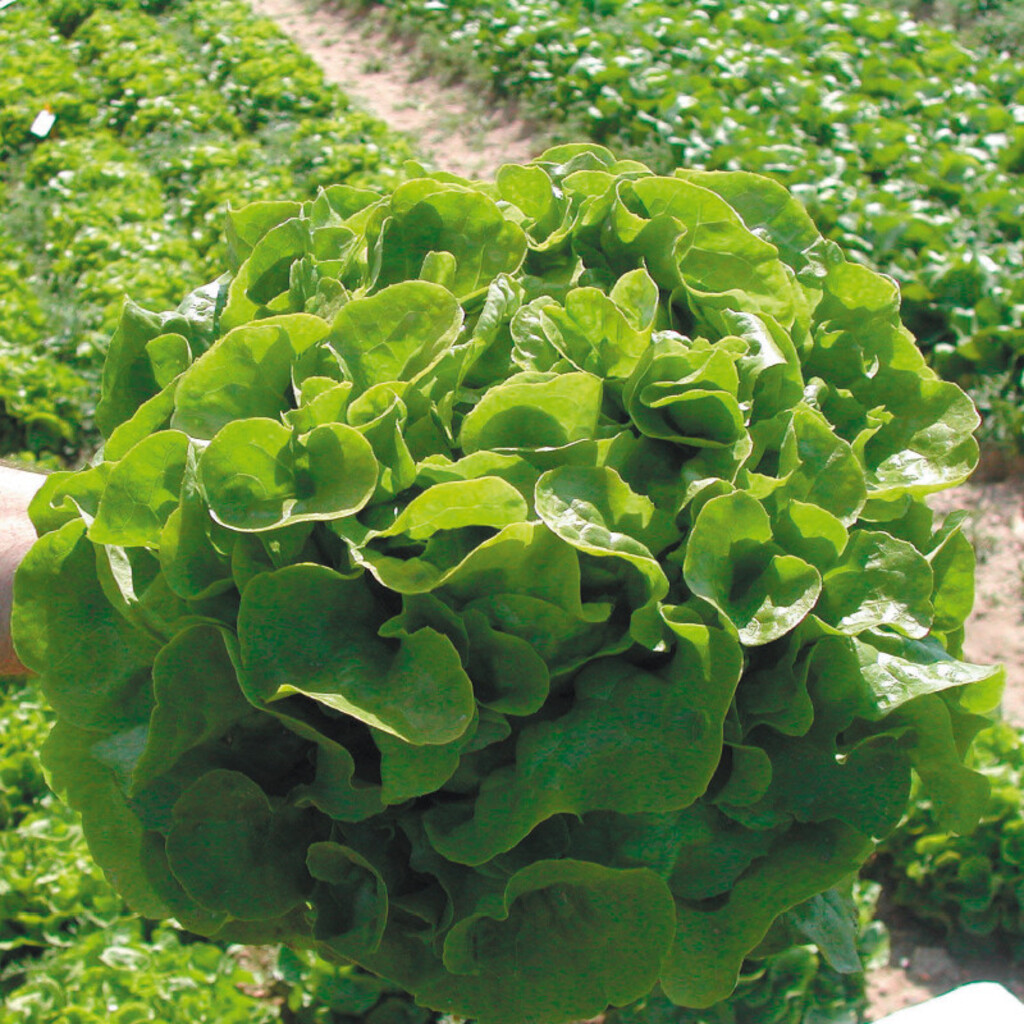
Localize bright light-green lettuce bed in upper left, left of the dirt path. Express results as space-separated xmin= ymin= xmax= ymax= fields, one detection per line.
xmin=0 ymin=0 xmax=410 ymax=460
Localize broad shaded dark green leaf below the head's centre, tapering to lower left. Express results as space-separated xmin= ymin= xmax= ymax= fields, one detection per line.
xmin=425 ymin=626 xmax=741 ymax=864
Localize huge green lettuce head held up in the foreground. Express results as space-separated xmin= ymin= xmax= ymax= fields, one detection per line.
xmin=14 ymin=145 xmax=1001 ymax=1024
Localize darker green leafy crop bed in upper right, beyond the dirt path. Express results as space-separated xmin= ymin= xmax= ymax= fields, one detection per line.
xmin=344 ymin=0 xmax=1024 ymax=452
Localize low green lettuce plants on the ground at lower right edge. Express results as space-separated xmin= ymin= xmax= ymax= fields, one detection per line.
xmin=870 ymin=722 xmax=1024 ymax=955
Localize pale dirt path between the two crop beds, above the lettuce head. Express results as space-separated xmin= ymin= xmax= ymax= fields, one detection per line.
xmin=251 ymin=0 xmax=544 ymax=177
